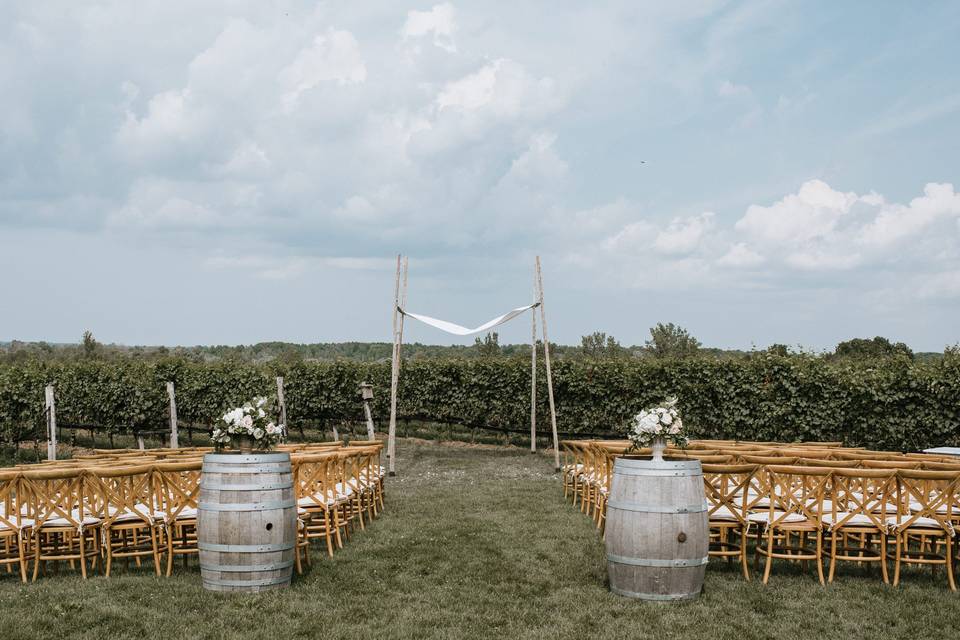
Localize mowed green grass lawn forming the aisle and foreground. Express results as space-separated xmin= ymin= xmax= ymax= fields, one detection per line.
xmin=0 ymin=442 xmax=960 ymax=640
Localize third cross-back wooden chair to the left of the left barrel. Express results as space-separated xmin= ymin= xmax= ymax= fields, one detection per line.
xmin=20 ymin=468 xmax=101 ymax=581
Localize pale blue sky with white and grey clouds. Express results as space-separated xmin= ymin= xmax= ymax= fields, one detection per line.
xmin=0 ymin=0 xmax=960 ymax=351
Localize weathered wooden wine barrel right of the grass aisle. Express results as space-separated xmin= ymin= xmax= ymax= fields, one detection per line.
xmin=605 ymin=458 xmax=709 ymax=601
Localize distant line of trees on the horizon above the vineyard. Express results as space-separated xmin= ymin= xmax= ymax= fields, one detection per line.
xmin=0 ymin=323 xmax=944 ymax=363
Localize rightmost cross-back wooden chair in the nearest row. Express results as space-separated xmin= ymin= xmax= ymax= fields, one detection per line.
xmin=887 ymin=469 xmax=960 ymax=591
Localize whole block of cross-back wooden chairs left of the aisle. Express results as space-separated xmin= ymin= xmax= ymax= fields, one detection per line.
xmin=0 ymin=441 xmax=384 ymax=581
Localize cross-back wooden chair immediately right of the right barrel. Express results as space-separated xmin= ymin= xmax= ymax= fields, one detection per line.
xmin=703 ymin=464 xmax=759 ymax=580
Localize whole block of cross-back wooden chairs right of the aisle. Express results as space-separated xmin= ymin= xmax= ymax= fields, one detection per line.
xmin=562 ymin=441 xmax=960 ymax=590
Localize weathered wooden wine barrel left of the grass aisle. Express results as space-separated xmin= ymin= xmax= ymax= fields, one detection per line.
xmin=197 ymin=453 xmax=297 ymax=591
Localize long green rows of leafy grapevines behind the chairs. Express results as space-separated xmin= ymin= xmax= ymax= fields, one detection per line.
xmin=0 ymin=354 xmax=960 ymax=450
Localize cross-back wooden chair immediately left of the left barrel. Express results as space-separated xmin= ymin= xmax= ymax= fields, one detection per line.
xmin=153 ymin=460 xmax=203 ymax=576
